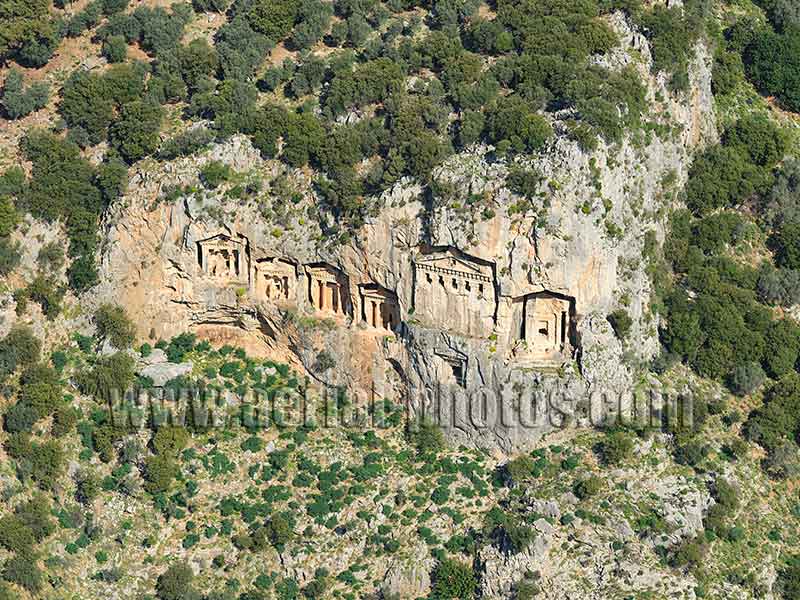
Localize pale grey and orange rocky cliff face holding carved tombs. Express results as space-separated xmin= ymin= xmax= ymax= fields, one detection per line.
xmin=98 ymin=16 xmax=715 ymax=451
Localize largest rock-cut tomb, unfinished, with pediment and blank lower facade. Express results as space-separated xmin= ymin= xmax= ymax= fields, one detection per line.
xmin=413 ymin=248 xmax=496 ymax=337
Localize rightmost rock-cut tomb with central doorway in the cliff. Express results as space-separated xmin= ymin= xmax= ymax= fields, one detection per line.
xmin=514 ymin=290 xmax=575 ymax=362
